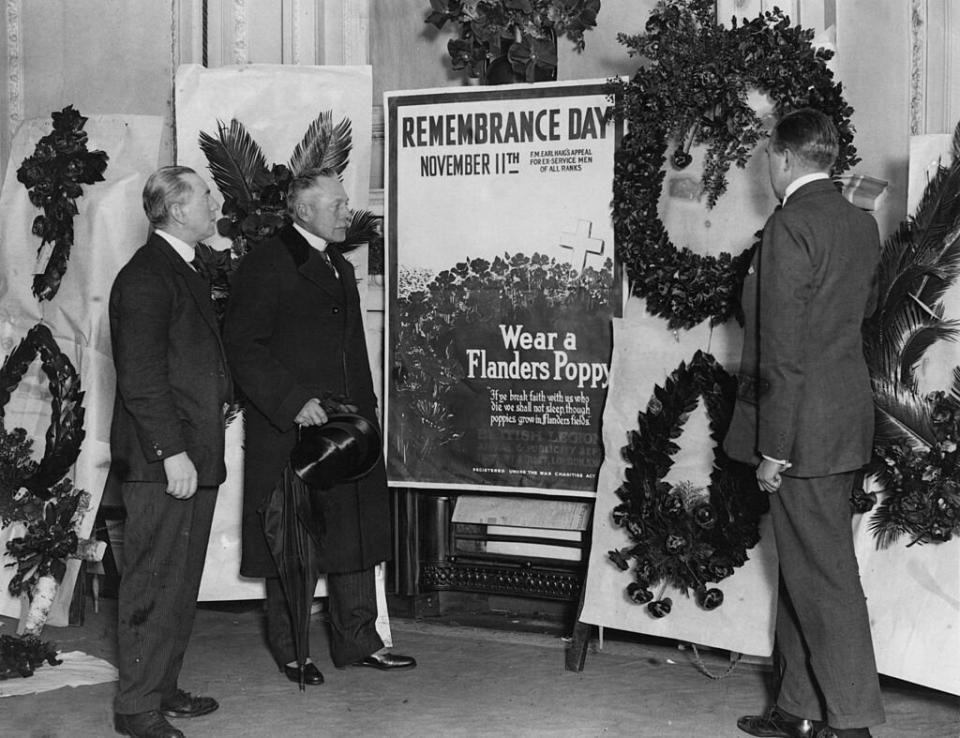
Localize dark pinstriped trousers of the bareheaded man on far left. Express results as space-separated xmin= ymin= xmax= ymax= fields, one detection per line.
xmin=114 ymin=482 xmax=217 ymax=714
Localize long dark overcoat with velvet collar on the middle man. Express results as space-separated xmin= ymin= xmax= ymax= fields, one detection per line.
xmin=224 ymin=226 xmax=391 ymax=577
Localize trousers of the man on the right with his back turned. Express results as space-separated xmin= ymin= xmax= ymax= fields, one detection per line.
xmin=770 ymin=472 xmax=884 ymax=728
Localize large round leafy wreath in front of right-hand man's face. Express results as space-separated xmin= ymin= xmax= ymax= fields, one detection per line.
xmin=612 ymin=0 xmax=859 ymax=329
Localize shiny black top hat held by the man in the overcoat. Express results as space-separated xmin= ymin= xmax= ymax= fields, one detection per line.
xmin=290 ymin=413 xmax=380 ymax=489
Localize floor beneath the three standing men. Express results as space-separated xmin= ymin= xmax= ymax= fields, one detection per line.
xmin=0 ymin=599 xmax=960 ymax=738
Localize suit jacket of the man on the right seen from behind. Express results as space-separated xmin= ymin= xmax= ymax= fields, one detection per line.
xmin=724 ymin=180 xmax=880 ymax=477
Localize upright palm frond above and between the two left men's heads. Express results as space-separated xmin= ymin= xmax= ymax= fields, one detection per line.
xmin=200 ymin=118 xmax=270 ymax=203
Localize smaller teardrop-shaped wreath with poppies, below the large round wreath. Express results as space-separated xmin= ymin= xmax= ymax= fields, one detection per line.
xmin=608 ymin=351 xmax=770 ymax=617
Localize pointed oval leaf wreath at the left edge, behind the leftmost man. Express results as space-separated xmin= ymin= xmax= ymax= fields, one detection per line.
xmin=0 ymin=323 xmax=84 ymax=500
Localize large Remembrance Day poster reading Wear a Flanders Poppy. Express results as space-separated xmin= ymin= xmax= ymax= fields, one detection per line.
xmin=384 ymin=81 xmax=621 ymax=495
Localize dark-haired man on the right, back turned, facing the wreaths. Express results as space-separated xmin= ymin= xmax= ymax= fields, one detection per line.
xmin=725 ymin=109 xmax=884 ymax=738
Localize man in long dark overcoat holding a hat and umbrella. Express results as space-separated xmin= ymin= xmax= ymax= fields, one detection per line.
xmin=224 ymin=170 xmax=416 ymax=685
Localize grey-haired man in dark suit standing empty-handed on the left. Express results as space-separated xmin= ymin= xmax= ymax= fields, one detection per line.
xmin=110 ymin=167 xmax=231 ymax=738
